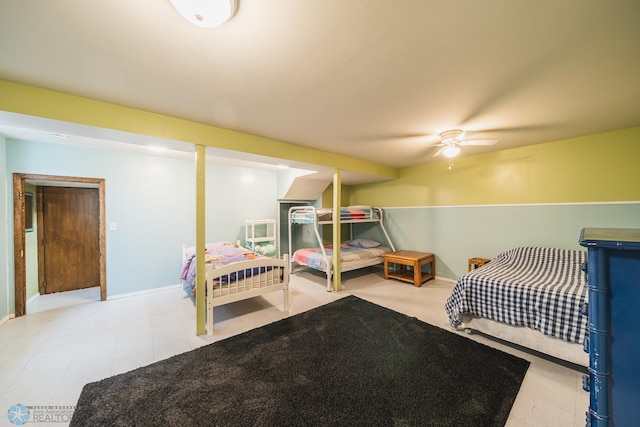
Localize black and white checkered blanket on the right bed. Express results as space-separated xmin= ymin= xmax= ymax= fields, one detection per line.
xmin=445 ymin=247 xmax=587 ymax=343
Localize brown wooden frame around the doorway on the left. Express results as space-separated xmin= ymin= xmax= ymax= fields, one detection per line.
xmin=13 ymin=173 xmax=107 ymax=317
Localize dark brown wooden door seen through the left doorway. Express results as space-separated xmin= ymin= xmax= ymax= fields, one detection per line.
xmin=38 ymin=187 xmax=100 ymax=294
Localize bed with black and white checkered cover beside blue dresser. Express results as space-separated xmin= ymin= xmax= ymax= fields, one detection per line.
xmin=445 ymin=247 xmax=588 ymax=366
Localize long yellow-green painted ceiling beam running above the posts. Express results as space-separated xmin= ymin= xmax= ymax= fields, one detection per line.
xmin=0 ymin=80 xmax=398 ymax=182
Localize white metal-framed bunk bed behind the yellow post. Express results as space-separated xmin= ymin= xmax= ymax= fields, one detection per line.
xmin=288 ymin=206 xmax=395 ymax=292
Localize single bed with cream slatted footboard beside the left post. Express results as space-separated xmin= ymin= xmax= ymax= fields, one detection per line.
xmin=180 ymin=242 xmax=290 ymax=335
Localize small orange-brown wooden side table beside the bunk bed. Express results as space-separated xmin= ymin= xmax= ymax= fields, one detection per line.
xmin=384 ymin=251 xmax=436 ymax=287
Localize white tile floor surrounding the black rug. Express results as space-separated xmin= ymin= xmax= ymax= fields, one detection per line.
xmin=0 ymin=268 xmax=589 ymax=427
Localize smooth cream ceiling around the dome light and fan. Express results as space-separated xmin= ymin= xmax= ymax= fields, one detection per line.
xmin=0 ymin=0 xmax=640 ymax=177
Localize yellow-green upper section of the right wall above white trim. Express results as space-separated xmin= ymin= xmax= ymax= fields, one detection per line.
xmin=350 ymin=128 xmax=640 ymax=206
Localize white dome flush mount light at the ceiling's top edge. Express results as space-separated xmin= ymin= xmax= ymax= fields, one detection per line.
xmin=170 ymin=0 xmax=238 ymax=28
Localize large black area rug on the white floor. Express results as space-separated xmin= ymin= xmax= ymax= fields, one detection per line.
xmin=71 ymin=296 xmax=529 ymax=427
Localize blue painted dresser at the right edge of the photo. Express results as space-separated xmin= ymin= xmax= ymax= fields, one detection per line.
xmin=580 ymin=228 xmax=640 ymax=427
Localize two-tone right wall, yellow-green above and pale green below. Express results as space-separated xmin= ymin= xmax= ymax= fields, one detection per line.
xmin=349 ymin=128 xmax=640 ymax=280
